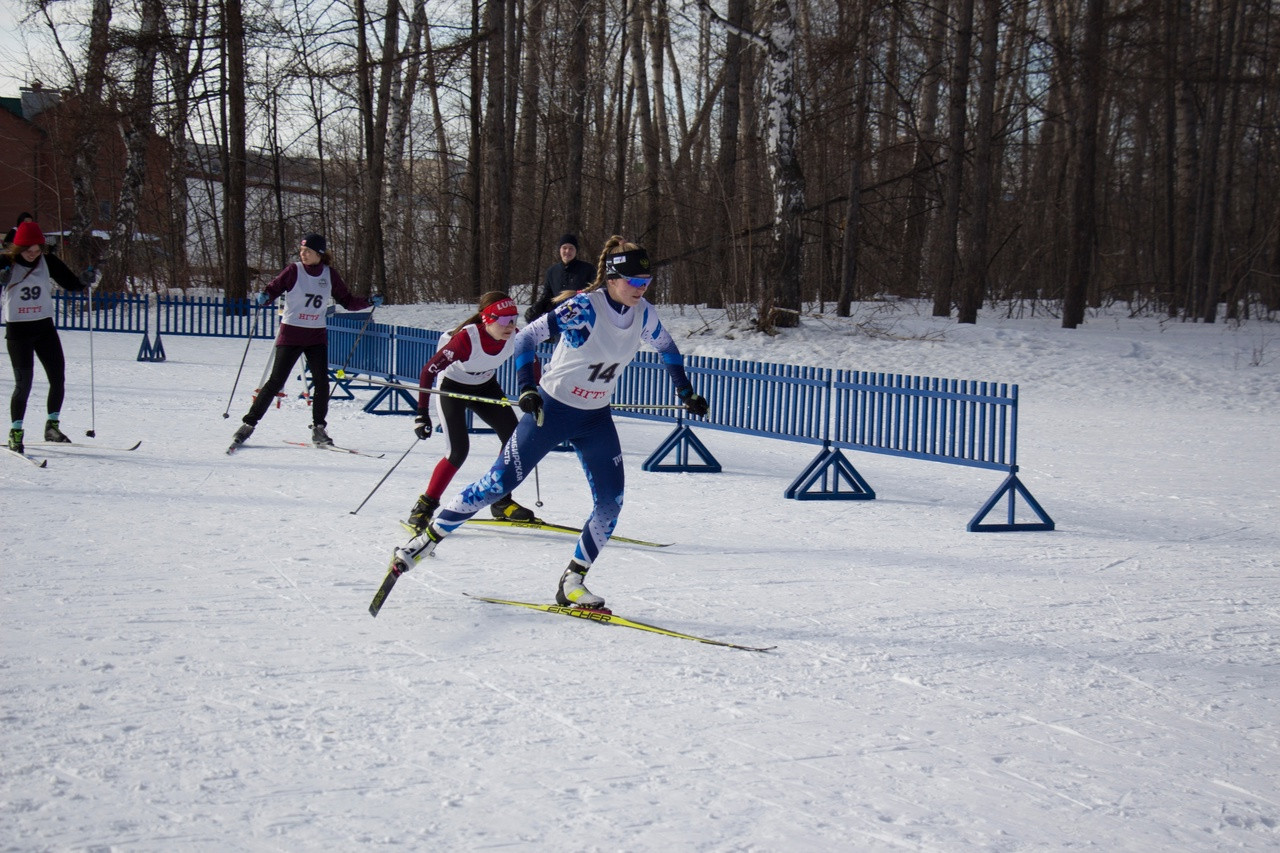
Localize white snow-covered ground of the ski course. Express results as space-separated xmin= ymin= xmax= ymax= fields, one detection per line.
xmin=0 ymin=298 xmax=1280 ymax=853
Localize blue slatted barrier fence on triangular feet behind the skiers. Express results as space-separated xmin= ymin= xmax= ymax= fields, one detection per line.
xmin=40 ymin=293 xmax=1055 ymax=532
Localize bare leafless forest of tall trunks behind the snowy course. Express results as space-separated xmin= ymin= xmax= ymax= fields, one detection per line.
xmin=6 ymin=0 xmax=1280 ymax=330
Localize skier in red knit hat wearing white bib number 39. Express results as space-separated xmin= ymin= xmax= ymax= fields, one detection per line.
xmin=0 ymin=220 xmax=93 ymax=453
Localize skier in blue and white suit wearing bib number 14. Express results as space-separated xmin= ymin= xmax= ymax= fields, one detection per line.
xmin=392 ymin=234 xmax=708 ymax=610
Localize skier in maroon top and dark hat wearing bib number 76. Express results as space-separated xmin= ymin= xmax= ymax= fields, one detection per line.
xmin=228 ymin=234 xmax=383 ymax=452
